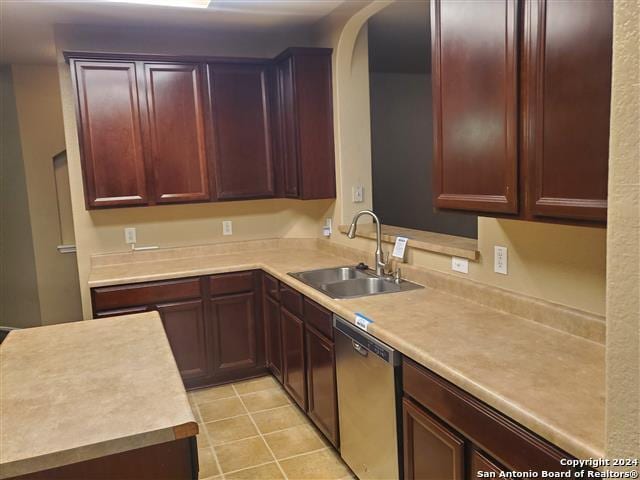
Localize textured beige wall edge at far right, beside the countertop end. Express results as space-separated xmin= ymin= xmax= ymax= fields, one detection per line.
xmin=606 ymin=0 xmax=640 ymax=458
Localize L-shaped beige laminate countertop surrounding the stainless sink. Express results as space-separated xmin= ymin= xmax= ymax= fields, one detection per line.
xmin=89 ymin=249 xmax=605 ymax=458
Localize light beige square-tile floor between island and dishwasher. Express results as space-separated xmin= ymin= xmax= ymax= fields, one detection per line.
xmin=189 ymin=376 xmax=355 ymax=480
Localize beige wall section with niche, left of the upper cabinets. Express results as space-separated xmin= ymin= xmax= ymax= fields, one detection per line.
xmin=11 ymin=65 xmax=82 ymax=325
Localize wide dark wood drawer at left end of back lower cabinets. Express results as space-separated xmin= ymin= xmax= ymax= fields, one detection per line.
xmin=92 ymin=278 xmax=200 ymax=312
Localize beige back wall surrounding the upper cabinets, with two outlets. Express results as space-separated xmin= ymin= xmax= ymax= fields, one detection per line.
xmin=56 ymin=26 xmax=333 ymax=318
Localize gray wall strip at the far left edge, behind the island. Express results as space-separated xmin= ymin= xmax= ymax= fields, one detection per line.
xmin=0 ymin=66 xmax=41 ymax=327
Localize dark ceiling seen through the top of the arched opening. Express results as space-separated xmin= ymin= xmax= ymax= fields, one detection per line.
xmin=369 ymin=0 xmax=431 ymax=73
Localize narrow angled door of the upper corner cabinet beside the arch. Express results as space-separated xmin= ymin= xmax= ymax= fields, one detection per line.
xmin=276 ymin=57 xmax=300 ymax=198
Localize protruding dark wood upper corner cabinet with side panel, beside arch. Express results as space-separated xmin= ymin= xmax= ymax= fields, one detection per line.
xmin=274 ymin=48 xmax=336 ymax=199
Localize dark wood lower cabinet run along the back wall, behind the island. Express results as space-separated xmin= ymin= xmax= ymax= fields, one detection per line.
xmin=91 ymin=271 xmax=267 ymax=388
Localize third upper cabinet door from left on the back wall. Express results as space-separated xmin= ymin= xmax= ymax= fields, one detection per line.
xmin=208 ymin=64 xmax=275 ymax=200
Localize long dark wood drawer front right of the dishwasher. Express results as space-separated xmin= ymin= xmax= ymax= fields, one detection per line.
xmin=402 ymin=360 xmax=569 ymax=471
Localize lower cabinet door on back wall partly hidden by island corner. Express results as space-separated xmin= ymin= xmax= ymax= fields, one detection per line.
xmin=156 ymin=300 xmax=209 ymax=384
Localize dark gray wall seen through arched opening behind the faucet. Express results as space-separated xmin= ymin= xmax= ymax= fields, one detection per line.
xmin=369 ymin=72 xmax=478 ymax=238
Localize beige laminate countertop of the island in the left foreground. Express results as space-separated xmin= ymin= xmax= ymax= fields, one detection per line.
xmin=0 ymin=312 xmax=198 ymax=478
